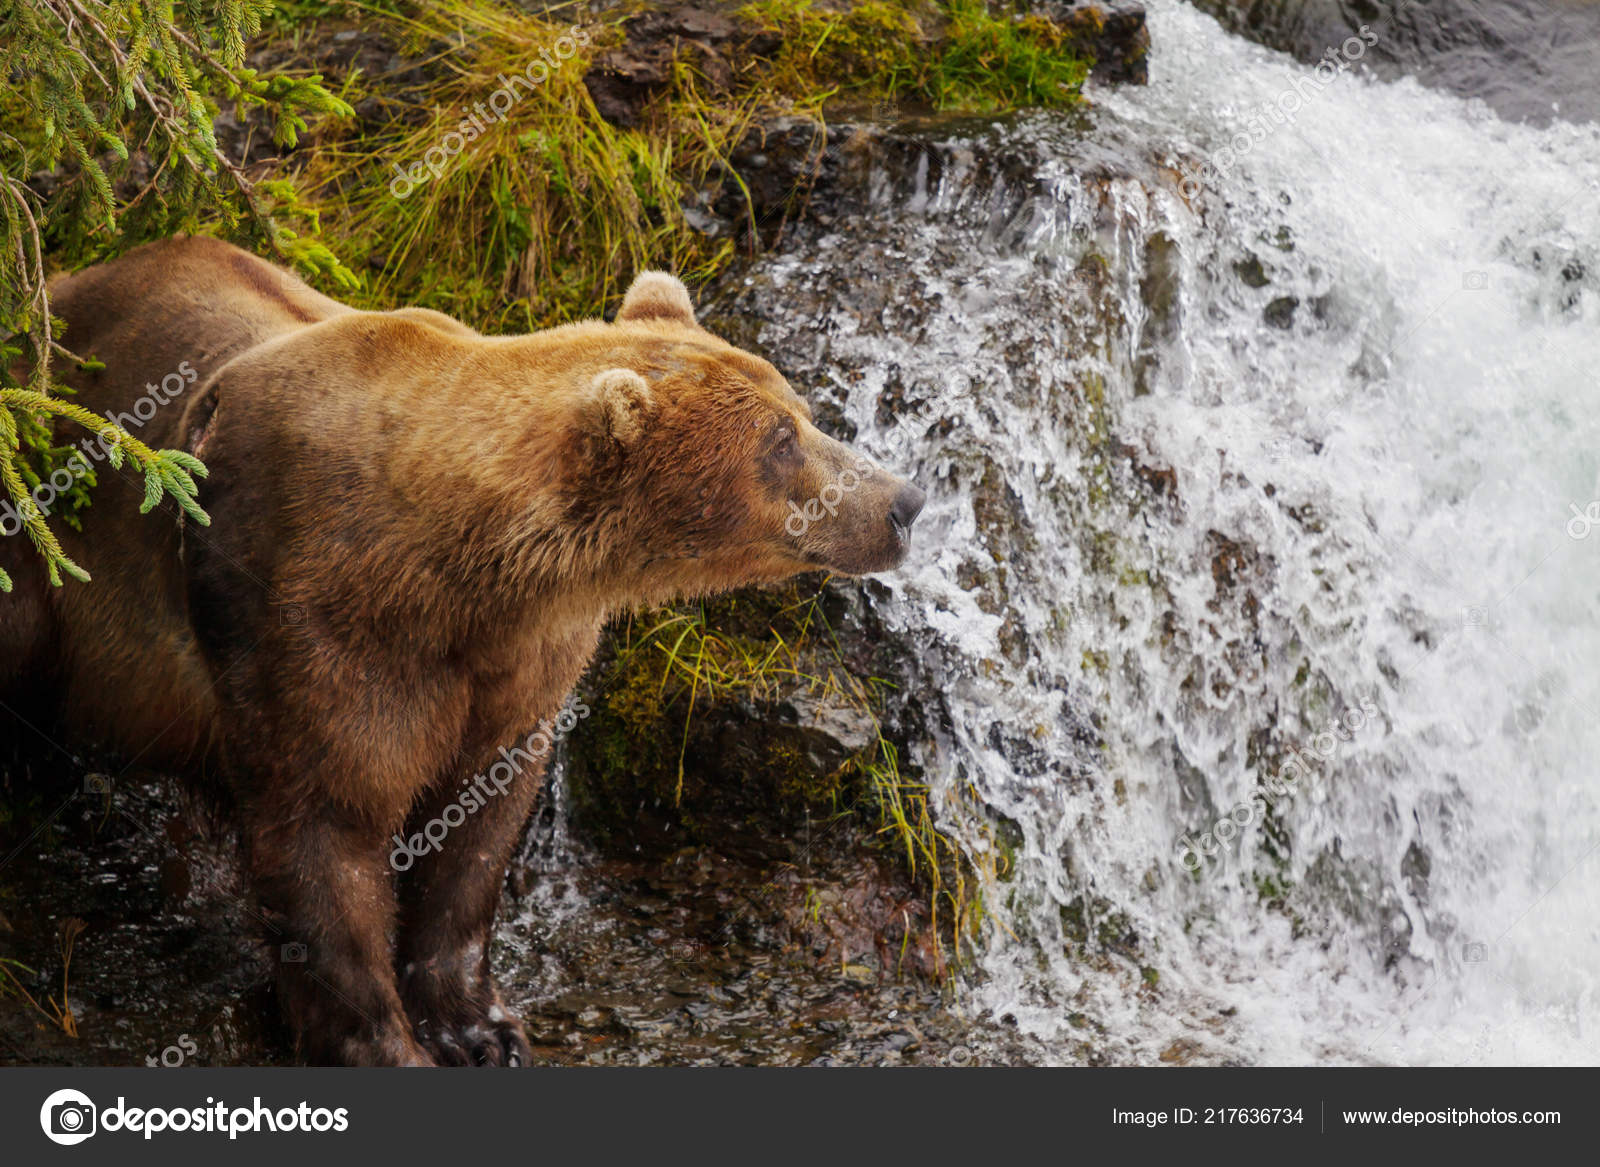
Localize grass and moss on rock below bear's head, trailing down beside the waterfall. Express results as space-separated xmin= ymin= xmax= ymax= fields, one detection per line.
xmin=573 ymin=589 xmax=1008 ymax=978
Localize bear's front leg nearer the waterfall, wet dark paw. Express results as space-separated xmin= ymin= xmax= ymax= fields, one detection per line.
xmin=390 ymin=759 xmax=542 ymax=1066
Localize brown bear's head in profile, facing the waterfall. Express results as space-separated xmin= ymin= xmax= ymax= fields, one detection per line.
xmin=566 ymin=272 xmax=925 ymax=600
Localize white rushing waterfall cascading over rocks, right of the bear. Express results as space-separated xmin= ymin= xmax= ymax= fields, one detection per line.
xmin=734 ymin=0 xmax=1600 ymax=1065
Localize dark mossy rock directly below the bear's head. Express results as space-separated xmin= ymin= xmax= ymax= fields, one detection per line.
xmin=568 ymin=588 xmax=878 ymax=847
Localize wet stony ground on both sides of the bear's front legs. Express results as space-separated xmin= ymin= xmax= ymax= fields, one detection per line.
xmin=0 ymin=772 xmax=1029 ymax=1066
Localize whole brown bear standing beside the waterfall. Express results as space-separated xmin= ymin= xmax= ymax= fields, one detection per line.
xmin=0 ymin=237 xmax=923 ymax=1065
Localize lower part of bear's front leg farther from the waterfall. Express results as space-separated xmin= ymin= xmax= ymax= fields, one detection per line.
xmin=245 ymin=805 xmax=434 ymax=1066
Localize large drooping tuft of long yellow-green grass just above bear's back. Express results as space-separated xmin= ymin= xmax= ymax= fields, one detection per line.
xmin=292 ymin=0 xmax=739 ymax=331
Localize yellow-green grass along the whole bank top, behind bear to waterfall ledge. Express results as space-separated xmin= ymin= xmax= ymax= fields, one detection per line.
xmin=284 ymin=0 xmax=1086 ymax=331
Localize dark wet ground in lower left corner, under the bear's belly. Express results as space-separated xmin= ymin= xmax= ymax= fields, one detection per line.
xmin=0 ymin=764 xmax=281 ymax=1066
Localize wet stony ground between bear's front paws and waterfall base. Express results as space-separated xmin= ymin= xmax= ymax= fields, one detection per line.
xmin=494 ymin=829 xmax=1026 ymax=1065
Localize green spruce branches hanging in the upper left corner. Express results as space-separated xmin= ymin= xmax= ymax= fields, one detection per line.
xmin=0 ymin=0 xmax=355 ymax=591
